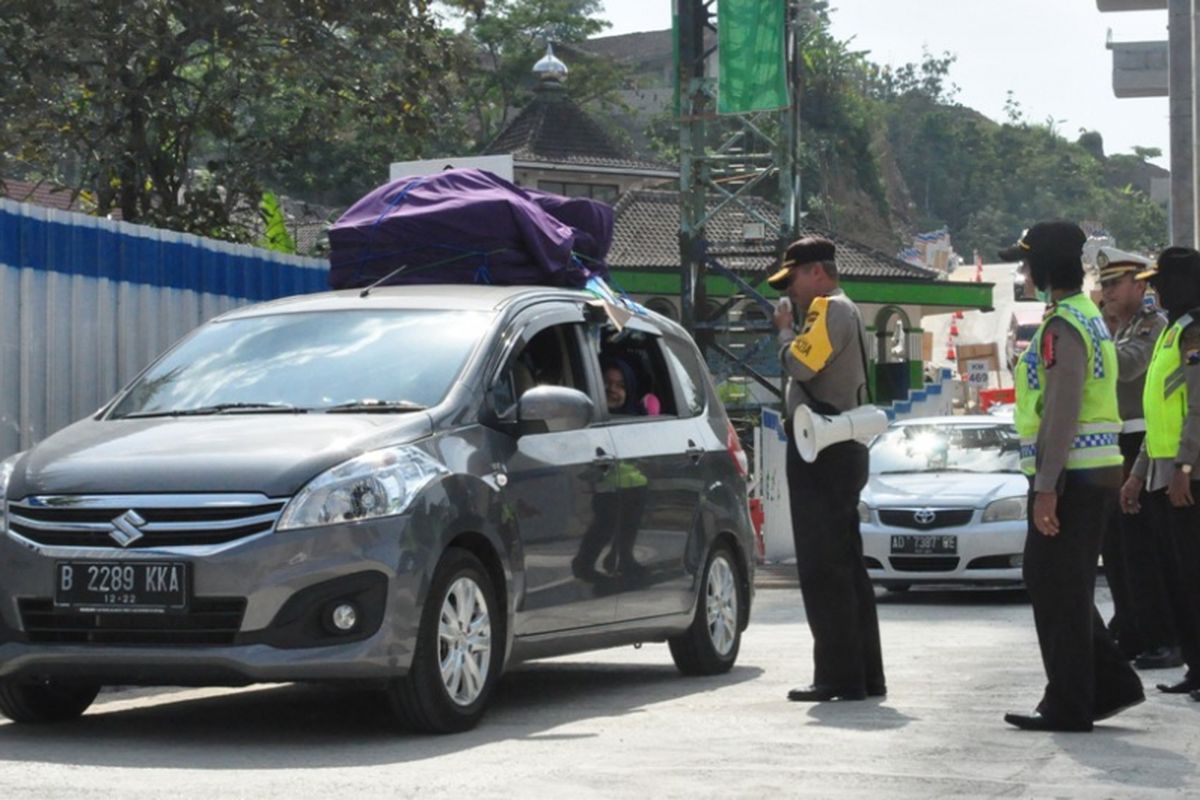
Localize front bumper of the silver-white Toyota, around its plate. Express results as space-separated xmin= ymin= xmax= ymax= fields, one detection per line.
xmin=862 ymin=513 xmax=1026 ymax=585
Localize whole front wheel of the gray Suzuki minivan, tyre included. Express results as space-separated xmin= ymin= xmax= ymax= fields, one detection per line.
xmin=388 ymin=547 xmax=504 ymax=733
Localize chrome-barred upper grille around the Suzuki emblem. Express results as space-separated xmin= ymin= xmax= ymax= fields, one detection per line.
xmin=8 ymin=494 xmax=287 ymax=549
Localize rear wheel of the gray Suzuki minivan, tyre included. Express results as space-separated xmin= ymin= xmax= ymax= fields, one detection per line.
xmin=667 ymin=545 xmax=742 ymax=675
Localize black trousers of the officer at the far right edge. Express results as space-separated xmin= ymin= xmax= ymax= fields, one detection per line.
xmin=1148 ymin=481 xmax=1200 ymax=679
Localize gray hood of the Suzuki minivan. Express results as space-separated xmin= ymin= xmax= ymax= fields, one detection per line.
xmin=7 ymin=413 xmax=432 ymax=499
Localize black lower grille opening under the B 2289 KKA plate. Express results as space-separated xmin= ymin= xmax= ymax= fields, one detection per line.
xmin=18 ymin=597 xmax=246 ymax=645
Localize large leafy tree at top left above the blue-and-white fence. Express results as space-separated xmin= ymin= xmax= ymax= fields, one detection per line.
xmin=0 ymin=0 xmax=461 ymax=239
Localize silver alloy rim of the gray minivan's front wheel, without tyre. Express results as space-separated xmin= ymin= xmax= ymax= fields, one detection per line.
xmin=438 ymin=577 xmax=492 ymax=705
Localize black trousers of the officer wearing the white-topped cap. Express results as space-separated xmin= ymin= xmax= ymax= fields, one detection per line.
xmin=1103 ymin=433 xmax=1176 ymax=657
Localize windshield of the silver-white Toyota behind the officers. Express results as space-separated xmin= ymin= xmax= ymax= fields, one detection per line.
xmin=871 ymin=423 xmax=1021 ymax=474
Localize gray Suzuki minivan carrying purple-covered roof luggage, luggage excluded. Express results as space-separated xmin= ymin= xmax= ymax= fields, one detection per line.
xmin=0 ymin=285 xmax=754 ymax=732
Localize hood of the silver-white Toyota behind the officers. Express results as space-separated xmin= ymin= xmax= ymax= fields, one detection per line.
xmin=862 ymin=471 xmax=1030 ymax=509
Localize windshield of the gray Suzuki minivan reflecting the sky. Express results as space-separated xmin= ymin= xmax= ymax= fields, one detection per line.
xmin=110 ymin=309 xmax=492 ymax=417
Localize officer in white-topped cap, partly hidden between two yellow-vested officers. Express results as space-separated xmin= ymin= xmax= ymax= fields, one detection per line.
xmin=1096 ymin=247 xmax=1182 ymax=669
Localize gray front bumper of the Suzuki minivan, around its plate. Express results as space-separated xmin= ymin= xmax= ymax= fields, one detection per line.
xmin=0 ymin=517 xmax=430 ymax=685
